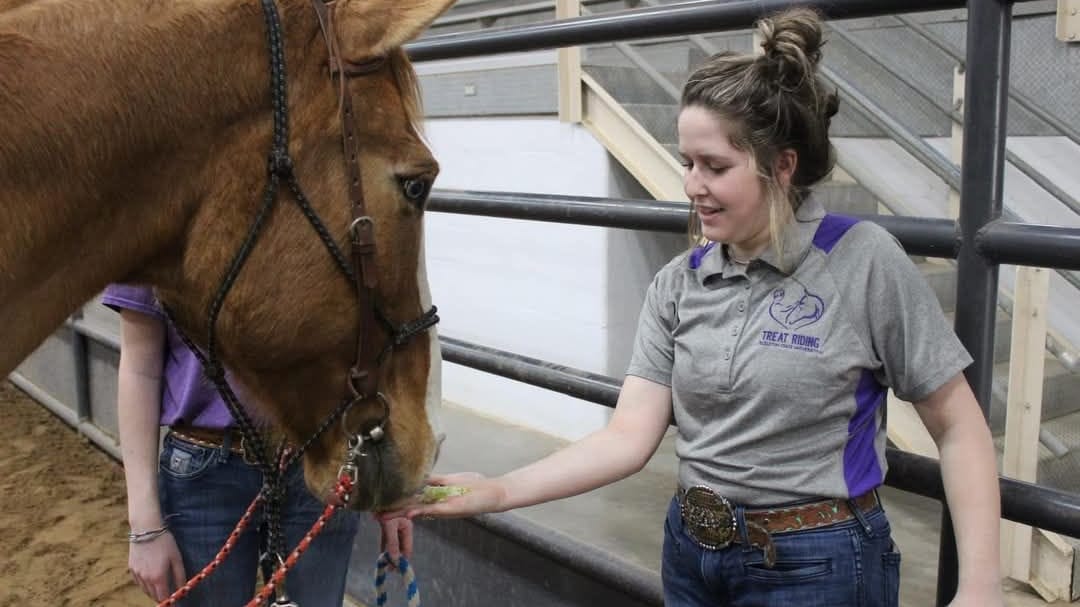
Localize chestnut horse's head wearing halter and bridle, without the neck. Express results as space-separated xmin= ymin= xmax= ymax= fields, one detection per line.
xmin=165 ymin=0 xmax=449 ymax=509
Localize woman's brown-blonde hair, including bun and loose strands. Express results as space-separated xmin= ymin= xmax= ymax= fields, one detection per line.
xmin=680 ymin=9 xmax=839 ymax=260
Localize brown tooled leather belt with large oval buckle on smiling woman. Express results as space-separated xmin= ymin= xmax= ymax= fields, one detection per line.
xmin=677 ymin=485 xmax=878 ymax=567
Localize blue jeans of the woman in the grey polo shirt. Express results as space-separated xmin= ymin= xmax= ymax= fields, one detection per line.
xmin=662 ymin=499 xmax=900 ymax=607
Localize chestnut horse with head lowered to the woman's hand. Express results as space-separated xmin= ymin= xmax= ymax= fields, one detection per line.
xmin=0 ymin=0 xmax=453 ymax=510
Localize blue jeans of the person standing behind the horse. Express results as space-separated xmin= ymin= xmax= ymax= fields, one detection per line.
xmin=159 ymin=435 xmax=359 ymax=607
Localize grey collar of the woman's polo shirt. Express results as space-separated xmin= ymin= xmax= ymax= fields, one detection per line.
xmin=690 ymin=195 xmax=825 ymax=282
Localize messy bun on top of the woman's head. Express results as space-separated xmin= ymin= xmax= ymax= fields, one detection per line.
xmin=757 ymin=8 xmax=825 ymax=90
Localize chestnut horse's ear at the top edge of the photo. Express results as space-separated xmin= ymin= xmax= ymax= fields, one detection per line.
xmin=335 ymin=0 xmax=455 ymax=60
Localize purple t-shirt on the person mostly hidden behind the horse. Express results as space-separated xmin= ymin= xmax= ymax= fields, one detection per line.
xmin=102 ymin=284 xmax=233 ymax=429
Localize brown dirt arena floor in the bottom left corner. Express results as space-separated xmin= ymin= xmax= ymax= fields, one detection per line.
xmin=0 ymin=380 xmax=147 ymax=607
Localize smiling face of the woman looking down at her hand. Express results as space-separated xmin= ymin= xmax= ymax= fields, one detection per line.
xmin=678 ymin=106 xmax=769 ymax=257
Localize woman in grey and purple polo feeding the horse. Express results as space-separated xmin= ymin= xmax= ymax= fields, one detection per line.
xmin=388 ymin=10 xmax=1002 ymax=607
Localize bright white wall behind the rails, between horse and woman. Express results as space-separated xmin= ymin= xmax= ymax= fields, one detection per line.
xmin=426 ymin=117 xmax=685 ymax=440
